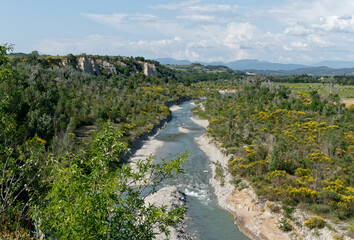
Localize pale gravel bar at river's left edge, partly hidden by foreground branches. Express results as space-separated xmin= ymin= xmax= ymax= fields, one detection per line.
xmin=145 ymin=186 xmax=192 ymax=240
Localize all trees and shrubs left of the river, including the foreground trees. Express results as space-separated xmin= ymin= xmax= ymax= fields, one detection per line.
xmin=0 ymin=45 xmax=196 ymax=239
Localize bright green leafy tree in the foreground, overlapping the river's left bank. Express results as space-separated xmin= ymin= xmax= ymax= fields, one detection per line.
xmin=36 ymin=122 xmax=187 ymax=239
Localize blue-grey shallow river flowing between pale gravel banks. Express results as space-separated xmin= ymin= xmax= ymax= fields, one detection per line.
xmin=155 ymin=102 xmax=248 ymax=240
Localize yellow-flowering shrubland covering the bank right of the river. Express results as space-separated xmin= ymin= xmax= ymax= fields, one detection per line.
xmin=195 ymin=78 xmax=354 ymax=236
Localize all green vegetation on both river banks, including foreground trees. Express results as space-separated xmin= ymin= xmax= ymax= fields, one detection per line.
xmin=0 ymin=45 xmax=354 ymax=239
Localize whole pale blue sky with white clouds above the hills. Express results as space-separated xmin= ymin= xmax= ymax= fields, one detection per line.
xmin=0 ymin=0 xmax=354 ymax=64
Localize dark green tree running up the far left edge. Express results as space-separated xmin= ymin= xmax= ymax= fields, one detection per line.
xmin=0 ymin=44 xmax=45 ymax=239
